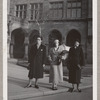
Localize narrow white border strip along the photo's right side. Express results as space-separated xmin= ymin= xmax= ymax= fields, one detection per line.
xmin=92 ymin=0 xmax=97 ymax=100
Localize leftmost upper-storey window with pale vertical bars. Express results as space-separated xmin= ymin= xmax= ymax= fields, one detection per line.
xmin=16 ymin=4 xmax=27 ymax=19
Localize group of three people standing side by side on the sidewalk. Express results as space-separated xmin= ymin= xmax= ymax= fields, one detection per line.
xmin=26 ymin=36 xmax=84 ymax=92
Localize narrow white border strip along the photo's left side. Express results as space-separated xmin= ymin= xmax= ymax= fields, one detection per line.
xmin=2 ymin=0 xmax=8 ymax=100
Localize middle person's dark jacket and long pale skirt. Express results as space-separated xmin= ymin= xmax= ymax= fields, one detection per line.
xmin=49 ymin=47 xmax=63 ymax=84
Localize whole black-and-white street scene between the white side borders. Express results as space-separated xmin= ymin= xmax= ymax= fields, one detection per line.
xmin=7 ymin=0 xmax=94 ymax=100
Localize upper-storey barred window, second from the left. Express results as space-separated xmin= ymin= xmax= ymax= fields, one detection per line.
xmin=30 ymin=3 xmax=43 ymax=20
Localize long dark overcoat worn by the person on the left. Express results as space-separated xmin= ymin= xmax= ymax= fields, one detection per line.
xmin=28 ymin=44 xmax=46 ymax=79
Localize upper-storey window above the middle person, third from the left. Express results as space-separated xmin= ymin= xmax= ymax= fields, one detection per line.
xmin=49 ymin=2 xmax=63 ymax=19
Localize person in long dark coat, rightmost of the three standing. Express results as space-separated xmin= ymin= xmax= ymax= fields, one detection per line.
xmin=68 ymin=40 xmax=84 ymax=92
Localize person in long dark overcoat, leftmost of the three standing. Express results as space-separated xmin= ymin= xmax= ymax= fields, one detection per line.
xmin=26 ymin=36 xmax=46 ymax=88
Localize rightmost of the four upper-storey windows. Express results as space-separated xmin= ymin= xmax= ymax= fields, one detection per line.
xmin=67 ymin=0 xmax=82 ymax=18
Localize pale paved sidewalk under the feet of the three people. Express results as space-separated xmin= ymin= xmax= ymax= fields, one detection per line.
xmin=8 ymin=61 xmax=92 ymax=100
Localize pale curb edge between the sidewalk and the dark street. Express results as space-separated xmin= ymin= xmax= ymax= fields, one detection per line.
xmin=8 ymin=85 xmax=92 ymax=100
